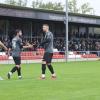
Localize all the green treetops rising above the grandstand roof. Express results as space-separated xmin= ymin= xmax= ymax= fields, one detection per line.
xmin=5 ymin=0 xmax=94 ymax=14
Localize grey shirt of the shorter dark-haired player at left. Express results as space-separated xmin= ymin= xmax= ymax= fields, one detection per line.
xmin=12 ymin=36 xmax=22 ymax=57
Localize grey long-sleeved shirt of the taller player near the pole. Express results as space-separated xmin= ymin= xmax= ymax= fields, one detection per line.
xmin=41 ymin=31 xmax=53 ymax=53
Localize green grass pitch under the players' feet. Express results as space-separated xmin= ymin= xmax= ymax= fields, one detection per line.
xmin=0 ymin=61 xmax=100 ymax=100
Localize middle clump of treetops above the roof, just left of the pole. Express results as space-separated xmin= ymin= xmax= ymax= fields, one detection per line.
xmin=32 ymin=0 xmax=64 ymax=11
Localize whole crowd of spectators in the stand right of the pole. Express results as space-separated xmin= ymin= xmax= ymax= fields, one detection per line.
xmin=68 ymin=32 xmax=100 ymax=51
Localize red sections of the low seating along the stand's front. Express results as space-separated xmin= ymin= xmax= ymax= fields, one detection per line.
xmin=0 ymin=49 xmax=98 ymax=61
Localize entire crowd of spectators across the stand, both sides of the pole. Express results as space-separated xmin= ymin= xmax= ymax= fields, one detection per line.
xmin=0 ymin=33 xmax=100 ymax=51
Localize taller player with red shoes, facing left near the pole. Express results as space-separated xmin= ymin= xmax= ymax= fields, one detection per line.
xmin=40 ymin=24 xmax=56 ymax=79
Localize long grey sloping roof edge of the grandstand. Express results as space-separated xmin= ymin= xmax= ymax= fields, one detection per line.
xmin=0 ymin=4 xmax=100 ymax=25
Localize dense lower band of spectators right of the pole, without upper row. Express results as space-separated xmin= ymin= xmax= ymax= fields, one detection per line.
xmin=69 ymin=39 xmax=100 ymax=51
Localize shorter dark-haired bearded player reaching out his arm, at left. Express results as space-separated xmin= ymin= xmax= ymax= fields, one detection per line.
xmin=7 ymin=29 xmax=32 ymax=79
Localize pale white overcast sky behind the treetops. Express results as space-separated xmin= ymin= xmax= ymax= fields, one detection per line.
xmin=0 ymin=0 xmax=100 ymax=15
